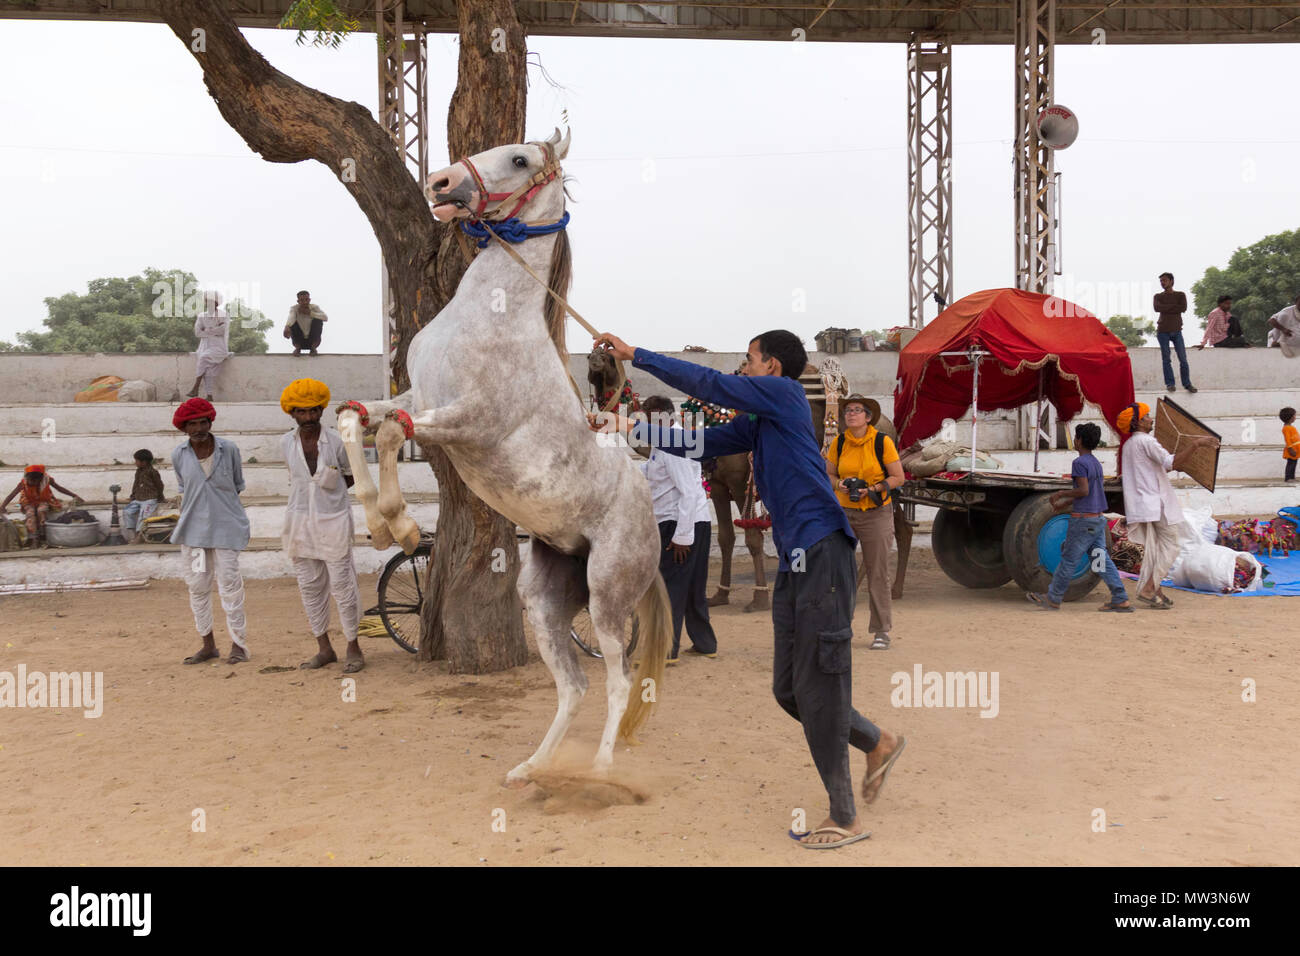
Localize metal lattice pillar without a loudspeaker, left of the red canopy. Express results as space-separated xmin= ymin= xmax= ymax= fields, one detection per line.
xmin=907 ymin=35 xmax=953 ymax=329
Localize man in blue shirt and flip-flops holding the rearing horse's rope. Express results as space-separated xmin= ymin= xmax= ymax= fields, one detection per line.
xmin=593 ymin=330 xmax=906 ymax=849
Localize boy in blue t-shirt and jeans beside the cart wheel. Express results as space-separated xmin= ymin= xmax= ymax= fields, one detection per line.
xmin=1026 ymin=423 xmax=1132 ymax=613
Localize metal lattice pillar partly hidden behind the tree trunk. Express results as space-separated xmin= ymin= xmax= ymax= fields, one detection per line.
xmin=374 ymin=0 xmax=429 ymax=395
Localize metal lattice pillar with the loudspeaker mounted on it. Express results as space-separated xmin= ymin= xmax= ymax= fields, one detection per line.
xmin=1014 ymin=0 xmax=1057 ymax=293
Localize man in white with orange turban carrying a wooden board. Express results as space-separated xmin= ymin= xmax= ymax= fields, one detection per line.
xmin=1115 ymin=402 xmax=1217 ymax=611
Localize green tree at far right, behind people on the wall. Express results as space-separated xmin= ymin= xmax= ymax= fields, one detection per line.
xmin=1192 ymin=229 xmax=1300 ymax=345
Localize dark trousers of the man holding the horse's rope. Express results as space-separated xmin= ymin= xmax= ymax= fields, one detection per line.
xmin=772 ymin=531 xmax=880 ymax=826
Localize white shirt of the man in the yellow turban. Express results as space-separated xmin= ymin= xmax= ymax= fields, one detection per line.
xmin=280 ymin=427 xmax=354 ymax=561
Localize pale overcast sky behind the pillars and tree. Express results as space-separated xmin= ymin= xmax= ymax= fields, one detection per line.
xmin=0 ymin=20 xmax=1300 ymax=352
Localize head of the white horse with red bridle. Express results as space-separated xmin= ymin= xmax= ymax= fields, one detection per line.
xmin=424 ymin=130 xmax=569 ymax=222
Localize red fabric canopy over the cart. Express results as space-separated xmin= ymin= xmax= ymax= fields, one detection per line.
xmin=894 ymin=289 xmax=1134 ymax=447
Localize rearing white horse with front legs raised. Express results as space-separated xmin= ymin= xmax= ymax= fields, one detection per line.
xmin=338 ymin=130 xmax=672 ymax=786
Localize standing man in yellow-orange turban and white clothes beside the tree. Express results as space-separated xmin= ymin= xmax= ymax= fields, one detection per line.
xmin=280 ymin=378 xmax=365 ymax=674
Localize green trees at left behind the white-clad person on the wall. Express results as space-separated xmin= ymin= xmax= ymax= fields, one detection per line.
xmin=0 ymin=269 xmax=273 ymax=355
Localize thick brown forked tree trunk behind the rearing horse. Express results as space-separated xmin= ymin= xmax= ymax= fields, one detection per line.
xmin=159 ymin=0 xmax=528 ymax=674
